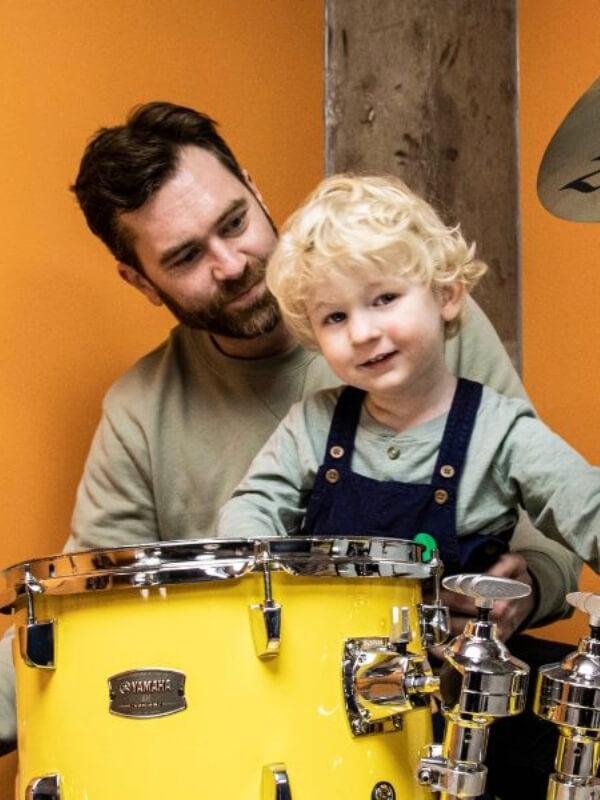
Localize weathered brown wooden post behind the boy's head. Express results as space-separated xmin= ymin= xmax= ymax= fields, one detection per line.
xmin=325 ymin=0 xmax=520 ymax=366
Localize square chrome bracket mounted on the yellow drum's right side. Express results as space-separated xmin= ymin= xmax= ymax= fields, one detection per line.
xmin=342 ymin=607 xmax=439 ymax=736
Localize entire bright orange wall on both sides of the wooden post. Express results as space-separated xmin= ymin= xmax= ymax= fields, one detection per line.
xmin=0 ymin=0 xmax=600 ymax=800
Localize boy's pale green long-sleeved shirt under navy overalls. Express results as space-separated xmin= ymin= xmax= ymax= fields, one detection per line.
xmin=218 ymin=386 xmax=600 ymax=571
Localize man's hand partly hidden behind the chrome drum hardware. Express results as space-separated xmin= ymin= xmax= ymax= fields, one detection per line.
xmin=442 ymin=553 xmax=535 ymax=641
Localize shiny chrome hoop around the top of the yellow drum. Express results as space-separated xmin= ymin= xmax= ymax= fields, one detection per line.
xmin=0 ymin=537 xmax=438 ymax=613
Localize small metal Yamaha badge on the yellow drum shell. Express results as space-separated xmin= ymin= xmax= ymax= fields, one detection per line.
xmin=108 ymin=669 xmax=187 ymax=718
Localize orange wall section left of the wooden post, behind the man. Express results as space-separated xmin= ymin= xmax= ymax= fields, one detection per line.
xmin=0 ymin=0 xmax=323 ymax=800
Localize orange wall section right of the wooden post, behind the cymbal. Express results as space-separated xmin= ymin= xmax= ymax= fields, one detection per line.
xmin=519 ymin=0 xmax=600 ymax=641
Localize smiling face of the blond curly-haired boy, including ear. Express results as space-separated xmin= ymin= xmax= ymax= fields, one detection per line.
xmin=307 ymin=275 xmax=464 ymax=398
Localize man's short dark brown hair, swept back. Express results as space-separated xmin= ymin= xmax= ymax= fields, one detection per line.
xmin=71 ymin=102 xmax=246 ymax=274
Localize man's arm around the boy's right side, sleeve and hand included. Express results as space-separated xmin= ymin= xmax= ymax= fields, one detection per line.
xmin=445 ymin=298 xmax=581 ymax=635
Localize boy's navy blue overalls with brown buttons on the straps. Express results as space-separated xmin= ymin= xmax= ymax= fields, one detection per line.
xmin=303 ymin=378 xmax=512 ymax=574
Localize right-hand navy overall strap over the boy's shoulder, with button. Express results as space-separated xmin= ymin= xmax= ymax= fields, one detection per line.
xmin=432 ymin=378 xmax=483 ymax=489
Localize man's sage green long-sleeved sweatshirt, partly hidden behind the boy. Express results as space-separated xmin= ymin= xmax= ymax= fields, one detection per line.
xmin=0 ymin=300 xmax=579 ymax=742
